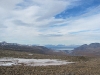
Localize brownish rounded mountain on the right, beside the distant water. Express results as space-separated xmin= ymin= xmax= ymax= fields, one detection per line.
xmin=71 ymin=43 xmax=100 ymax=56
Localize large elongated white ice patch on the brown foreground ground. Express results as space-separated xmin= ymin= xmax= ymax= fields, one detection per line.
xmin=0 ymin=58 xmax=74 ymax=66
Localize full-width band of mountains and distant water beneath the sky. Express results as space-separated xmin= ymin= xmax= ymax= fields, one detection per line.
xmin=0 ymin=42 xmax=100 ymax=56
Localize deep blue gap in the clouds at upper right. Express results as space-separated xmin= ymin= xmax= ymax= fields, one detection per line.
xmin=55 ymin=0 xmax=100 ymax=19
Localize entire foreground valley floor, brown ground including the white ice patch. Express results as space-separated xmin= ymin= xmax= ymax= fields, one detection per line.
xmin=0 ymin=50 xmax=100 ymax=75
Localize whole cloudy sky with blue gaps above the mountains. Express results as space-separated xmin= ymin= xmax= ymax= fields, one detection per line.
xmin=0 ymin=0 xmax=100 ymax=45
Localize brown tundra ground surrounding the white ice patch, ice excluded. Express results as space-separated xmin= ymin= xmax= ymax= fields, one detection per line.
xmin=0 ymin=50 xmax=100 ymax=75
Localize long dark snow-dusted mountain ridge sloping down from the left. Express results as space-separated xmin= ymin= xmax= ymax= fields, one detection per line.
xmin=0 ymin=41 xmax=66 ymax=55
